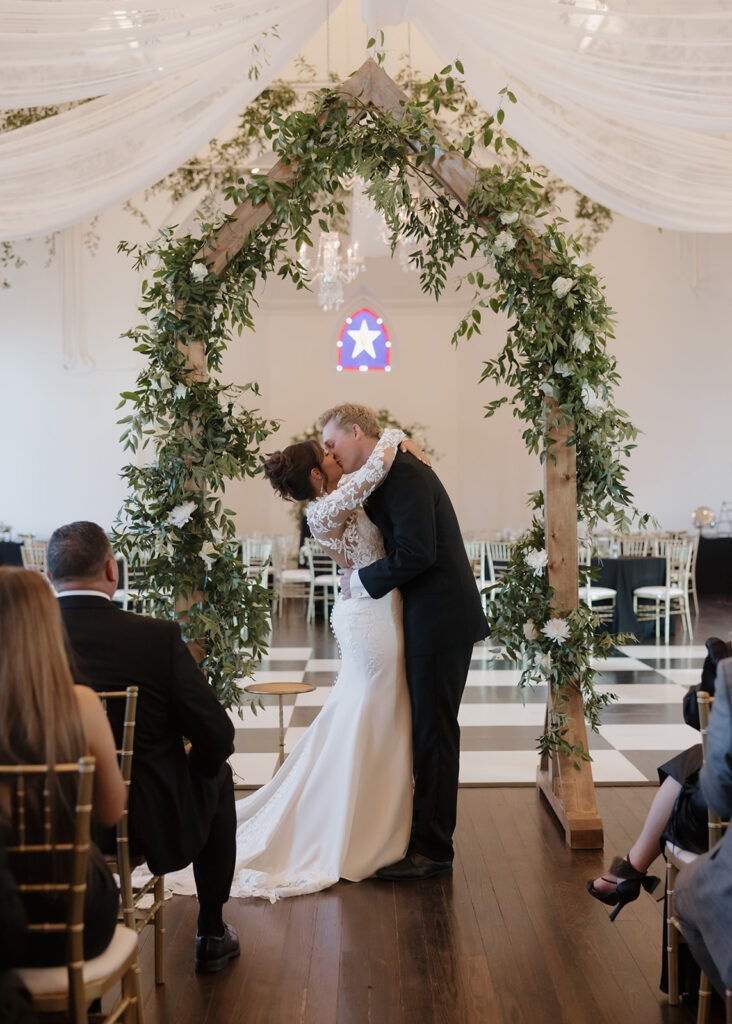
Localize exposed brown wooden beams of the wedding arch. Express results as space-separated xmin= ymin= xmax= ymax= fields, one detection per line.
xmin=185 ymin=59 xmax=603 ymax=849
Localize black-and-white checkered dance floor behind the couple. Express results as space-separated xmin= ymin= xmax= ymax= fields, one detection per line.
xmin=230 ymin=630 xmax=706 ymax=786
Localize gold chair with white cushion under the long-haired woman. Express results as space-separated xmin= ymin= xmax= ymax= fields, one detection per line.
xmin=5 ymin=757 xmax=142 ymax=1024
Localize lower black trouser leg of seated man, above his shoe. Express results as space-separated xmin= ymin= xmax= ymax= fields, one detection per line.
xmin=193 ymin=764 xmax=236 ymax=936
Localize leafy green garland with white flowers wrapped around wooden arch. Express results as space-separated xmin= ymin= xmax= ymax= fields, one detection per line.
xmin=114 ymin=48 xmax=637 ymax=758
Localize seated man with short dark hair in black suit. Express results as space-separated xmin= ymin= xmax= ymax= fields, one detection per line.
xmin=47 ymin=522 xmax=240 ymax=972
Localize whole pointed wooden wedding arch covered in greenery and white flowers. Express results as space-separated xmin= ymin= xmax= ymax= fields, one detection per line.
xmin=117 ymin=56 xmax=651 ymax=848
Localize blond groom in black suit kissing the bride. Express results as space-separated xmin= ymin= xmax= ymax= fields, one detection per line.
xmin=318 ymin=404 xmax=488 ymax=882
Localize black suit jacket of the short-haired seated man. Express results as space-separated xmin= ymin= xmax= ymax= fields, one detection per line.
xmin=59 ymin=595 xmax=233 ymax=874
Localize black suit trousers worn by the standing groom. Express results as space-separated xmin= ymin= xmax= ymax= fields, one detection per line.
xmin=406 ymin=644 xmax=473 ymax=860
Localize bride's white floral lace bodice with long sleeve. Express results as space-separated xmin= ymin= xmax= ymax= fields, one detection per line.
xmin=307 ymin=428 xmax=406 ymax=568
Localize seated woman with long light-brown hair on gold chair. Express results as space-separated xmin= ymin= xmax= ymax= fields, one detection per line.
xmin=0 ymin=566 xmax=125 ymax=967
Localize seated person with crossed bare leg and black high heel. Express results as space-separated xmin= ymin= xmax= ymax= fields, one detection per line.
xmin=587 ymin=637 xmax=731 ymax=917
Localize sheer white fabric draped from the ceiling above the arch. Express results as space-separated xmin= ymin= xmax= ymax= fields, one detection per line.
xmin=0 ymin=0 xmax=732 ymax=240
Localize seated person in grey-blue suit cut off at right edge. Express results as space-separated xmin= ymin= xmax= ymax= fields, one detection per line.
xmin=674 ymin=658 xmax=732 ymax=996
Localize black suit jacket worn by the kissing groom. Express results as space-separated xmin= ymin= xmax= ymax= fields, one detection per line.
xmin=358 ymin=452 xmax=488 ymax=657
